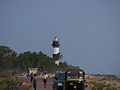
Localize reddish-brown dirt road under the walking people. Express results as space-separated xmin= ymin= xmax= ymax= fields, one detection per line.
xmin=29 ymin=79 xmax=52 ymax=90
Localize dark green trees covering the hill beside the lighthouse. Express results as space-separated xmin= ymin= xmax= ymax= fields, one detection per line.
xmin=0 ymin=46 xmax=78 ymax=72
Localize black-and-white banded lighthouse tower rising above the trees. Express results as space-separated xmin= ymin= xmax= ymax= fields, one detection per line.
xmin=52 ymin=37 xmax=60 ymax=65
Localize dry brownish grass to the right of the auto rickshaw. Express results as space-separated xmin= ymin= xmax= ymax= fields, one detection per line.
xmin=86 ymin=75 xmax=120 ymax=90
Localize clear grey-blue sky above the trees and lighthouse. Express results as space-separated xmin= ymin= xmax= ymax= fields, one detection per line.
xmin=0 ymin=0 xmax=120 ymax=74
